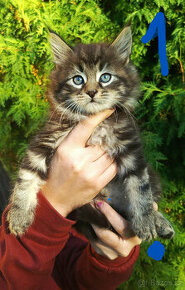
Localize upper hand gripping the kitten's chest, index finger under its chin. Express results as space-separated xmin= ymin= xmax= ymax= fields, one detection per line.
xmin=42 ymin=110 xmax=117 ymax=217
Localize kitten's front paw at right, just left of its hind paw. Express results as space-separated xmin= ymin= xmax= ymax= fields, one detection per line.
xmin=131 ymin=214 xmax=157 ymax=241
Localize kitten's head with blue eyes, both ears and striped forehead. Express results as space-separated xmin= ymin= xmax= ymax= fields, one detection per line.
xmin=48 ymin=27 xmax=138 ymax=115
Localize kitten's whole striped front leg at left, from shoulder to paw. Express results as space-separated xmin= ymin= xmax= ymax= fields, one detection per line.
xmin=7 ymin=124 xmax=69 ymax=235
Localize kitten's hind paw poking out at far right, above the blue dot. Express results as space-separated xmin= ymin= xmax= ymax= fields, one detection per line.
xmin=155 ymin=212 xmax=175 ymax=239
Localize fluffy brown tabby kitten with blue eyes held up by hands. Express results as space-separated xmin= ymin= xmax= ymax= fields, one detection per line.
xmin=7 ymin=26 xmax=174 ymax=240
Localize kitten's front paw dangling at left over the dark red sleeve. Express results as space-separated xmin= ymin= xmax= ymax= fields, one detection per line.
xmin=7 ymin=208 xmax=34 ymax=236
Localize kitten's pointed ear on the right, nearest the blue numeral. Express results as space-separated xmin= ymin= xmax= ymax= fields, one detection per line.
xmin=111 ymin=26 xmax=132 ymax=63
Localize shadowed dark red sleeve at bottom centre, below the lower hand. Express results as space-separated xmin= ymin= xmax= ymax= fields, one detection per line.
xmin=54 ymin=230 xmax=140 ymax=290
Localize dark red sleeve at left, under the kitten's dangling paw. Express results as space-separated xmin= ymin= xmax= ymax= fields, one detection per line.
xmin=0 ymin=191 xmax=74 ymax=290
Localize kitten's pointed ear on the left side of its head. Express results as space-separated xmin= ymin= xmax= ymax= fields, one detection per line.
xmin=49 ymin=30 xmax=73 ymax=65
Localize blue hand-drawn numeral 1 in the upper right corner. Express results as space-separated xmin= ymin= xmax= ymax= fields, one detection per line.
xmin=141 ymin=12 xmax=168 ymax=76
